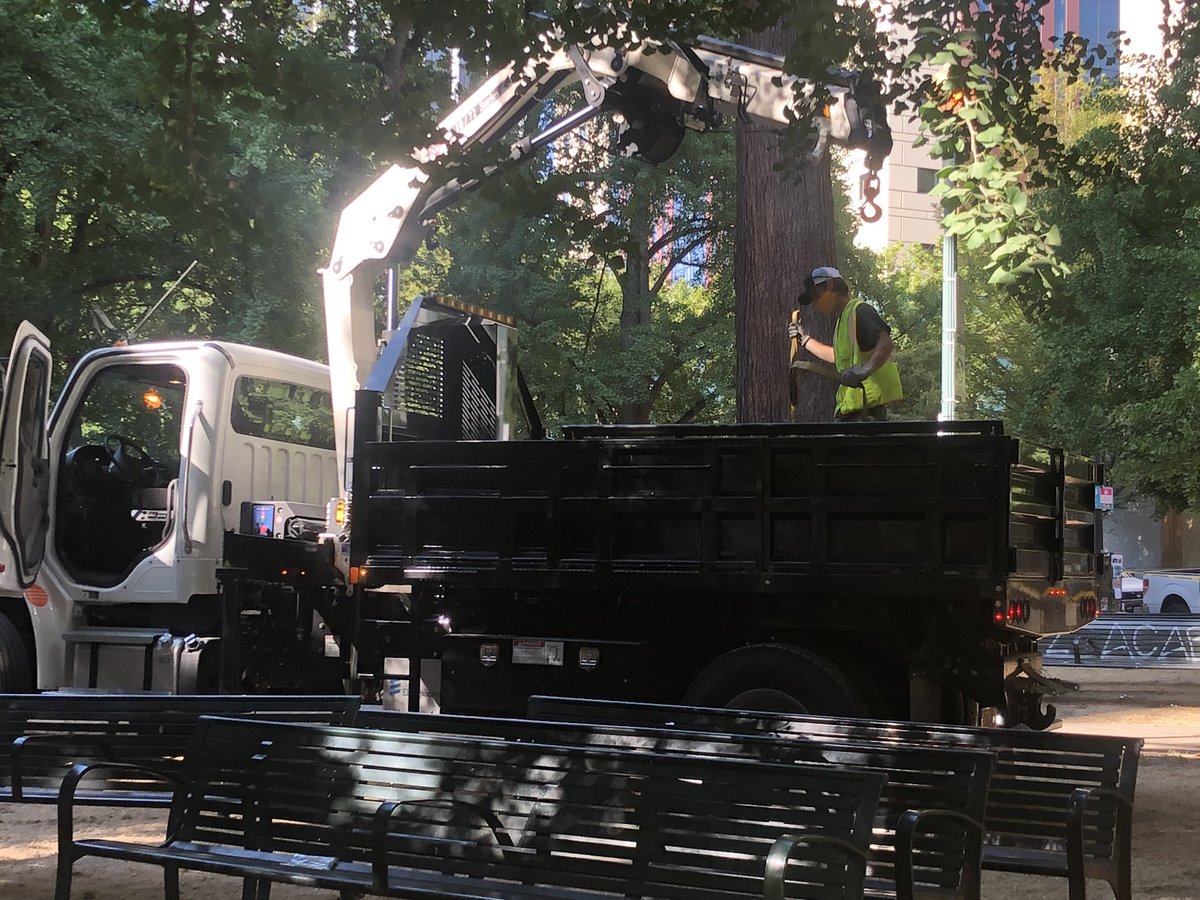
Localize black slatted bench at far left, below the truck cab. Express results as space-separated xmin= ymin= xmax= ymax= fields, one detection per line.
xmin=0 ymin=692 xmax=359 ymax=806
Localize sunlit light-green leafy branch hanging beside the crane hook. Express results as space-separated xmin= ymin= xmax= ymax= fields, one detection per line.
xmin=864 ymin=0 xmax=1109 ymax=290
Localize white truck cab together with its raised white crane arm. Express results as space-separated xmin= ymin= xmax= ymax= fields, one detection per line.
xmin=0 ymin=31 xmax=890 ymax=692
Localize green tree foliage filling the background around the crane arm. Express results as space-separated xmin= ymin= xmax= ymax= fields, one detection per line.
xmin=0 ymin=0 xmax=1180 ymax=465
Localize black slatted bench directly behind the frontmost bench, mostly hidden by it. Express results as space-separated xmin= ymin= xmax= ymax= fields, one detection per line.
xmin=355 ymin=707 xmax=995 ymax=900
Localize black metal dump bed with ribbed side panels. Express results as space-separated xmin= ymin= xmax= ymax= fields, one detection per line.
xmin=352 ymin=422 xmax=1100 ymax=634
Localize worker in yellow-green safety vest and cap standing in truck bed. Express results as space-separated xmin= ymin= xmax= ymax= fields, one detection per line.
xmin=787 ymin=265 xmax=904 ymax=421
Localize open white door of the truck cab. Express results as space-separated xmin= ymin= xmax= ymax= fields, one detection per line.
xmin=0 ymin=322 xmax=52 ymax=593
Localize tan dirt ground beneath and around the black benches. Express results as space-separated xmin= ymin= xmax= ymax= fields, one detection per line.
xmin=0 ymin=668 xmax=1200 ymax=900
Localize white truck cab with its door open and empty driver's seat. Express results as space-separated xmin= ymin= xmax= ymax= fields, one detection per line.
xmin=0 ymin=324 xmax=337 ymax=690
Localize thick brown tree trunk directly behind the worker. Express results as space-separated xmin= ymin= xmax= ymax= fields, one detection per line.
xmin=733 ymin=28 xmax=838 ymax=422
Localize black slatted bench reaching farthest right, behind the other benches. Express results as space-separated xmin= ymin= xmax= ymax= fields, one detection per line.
xmin=529 ymin=697 xmax=1142 ymax=900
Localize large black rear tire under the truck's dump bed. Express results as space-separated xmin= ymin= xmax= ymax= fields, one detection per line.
xmin=683 ymin=644 xmax=870 ymax=716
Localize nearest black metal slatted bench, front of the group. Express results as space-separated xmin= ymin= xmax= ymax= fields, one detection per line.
xmin=55 ymin=718 xmax=886 ymax=900
